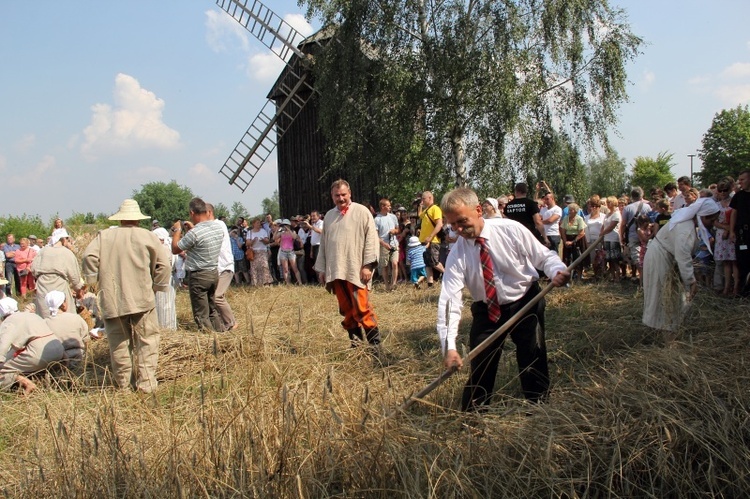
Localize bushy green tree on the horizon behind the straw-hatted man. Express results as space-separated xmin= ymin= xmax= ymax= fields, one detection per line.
xmin=133 ymin=180 xmax=195 ymax=227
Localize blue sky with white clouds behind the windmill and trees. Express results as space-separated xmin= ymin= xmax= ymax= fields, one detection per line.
xmin=0 ymin=0 xmax=750 ymax=221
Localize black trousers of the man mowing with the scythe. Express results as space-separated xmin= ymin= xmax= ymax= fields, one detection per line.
xmin=461 ymin=283 xmax=549 ymax=411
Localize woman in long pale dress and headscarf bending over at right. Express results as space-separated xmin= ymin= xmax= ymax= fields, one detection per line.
xmin=643 ymin=198 xmax=719 ymax=340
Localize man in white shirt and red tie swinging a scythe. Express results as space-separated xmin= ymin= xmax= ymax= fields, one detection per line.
xmin=437 ymin=188 xmax=570 ymax=410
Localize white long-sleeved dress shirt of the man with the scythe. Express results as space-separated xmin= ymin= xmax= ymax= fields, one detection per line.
xmin=437 ymin=218 xmax=566 ymax=353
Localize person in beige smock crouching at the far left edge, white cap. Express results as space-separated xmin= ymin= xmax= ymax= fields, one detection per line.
xmin=0 ymin=297 xmax=65 ymax=394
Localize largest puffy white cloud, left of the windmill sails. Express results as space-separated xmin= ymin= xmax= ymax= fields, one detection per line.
xmin=81 ymin=73 xmax=180 ymax=159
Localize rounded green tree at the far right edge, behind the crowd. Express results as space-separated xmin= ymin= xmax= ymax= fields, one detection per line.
xmin=695 ymin=105 xmax=750 ymax=186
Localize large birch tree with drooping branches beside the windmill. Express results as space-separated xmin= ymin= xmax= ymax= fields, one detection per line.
xmin=304 ymin=0 xmax=642 ymax=193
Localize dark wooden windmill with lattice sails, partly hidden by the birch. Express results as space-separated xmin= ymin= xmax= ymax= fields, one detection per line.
xmin=216 ymin=0 xmax=377 ymax=216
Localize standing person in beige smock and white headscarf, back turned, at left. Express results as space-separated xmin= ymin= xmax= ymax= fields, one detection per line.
xmin=31 ymin=229 xmax=86 ymax=319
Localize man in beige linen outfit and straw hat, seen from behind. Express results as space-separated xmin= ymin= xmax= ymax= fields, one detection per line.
xmin=83 ymin=199 xmax=171 ymax=393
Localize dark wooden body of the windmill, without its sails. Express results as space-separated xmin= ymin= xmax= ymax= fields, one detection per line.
xmin=268 ymin=35 xmax=379 ymax=217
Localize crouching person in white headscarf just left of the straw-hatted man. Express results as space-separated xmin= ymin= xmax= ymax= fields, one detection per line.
xmin=44 ymin=290 xmax=89 ymax=370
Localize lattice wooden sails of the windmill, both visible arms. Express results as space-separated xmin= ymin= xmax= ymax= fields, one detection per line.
xmin=216 ymin=0 xmax=324 ymax=192
